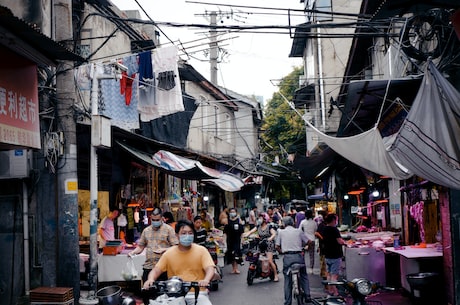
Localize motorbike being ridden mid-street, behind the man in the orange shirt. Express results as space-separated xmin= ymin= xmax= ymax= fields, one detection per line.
xmin=246 ymin=239 xmax=278 ymax=285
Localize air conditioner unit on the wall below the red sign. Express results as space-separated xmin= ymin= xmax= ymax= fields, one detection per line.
xmin=0 ymin=149 xmax=30 ymax=179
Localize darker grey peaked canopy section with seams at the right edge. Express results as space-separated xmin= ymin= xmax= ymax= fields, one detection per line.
xmin=390 ymin=61 xmax=460 ymax=189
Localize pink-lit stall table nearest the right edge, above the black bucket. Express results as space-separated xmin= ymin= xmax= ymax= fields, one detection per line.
xmin=384 ymin=244 xmax=442 ymax=291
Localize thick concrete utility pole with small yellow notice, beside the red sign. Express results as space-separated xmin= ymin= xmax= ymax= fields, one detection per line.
xmin=53 ymin=0 xmax=80 ymax=300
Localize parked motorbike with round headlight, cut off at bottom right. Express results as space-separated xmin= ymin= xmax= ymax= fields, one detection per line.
xmin=312 ymin=278 xmax=394 ymax=305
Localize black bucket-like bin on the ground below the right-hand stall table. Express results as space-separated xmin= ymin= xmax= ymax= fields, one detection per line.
xmin=406 ymin=272 xmax=441 ymax=305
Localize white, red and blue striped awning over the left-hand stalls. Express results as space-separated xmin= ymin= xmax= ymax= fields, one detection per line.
xmin=118 ymin=142 xmax=244 ymax=192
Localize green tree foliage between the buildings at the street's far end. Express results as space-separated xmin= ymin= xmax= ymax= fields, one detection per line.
xmin=262 ymin=67 xmax=305 ymax=163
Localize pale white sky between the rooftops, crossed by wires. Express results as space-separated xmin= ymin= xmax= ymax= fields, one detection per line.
xmin=111 ymin=0 xmax=305 ymax=101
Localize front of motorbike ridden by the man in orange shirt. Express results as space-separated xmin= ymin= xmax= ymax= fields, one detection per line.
xmin=142 ymin=276 xmax=205 ymax=305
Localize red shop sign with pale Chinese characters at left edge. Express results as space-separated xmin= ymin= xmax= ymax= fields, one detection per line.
xmin=0 ymin=47 xmax=41 ymax=148
